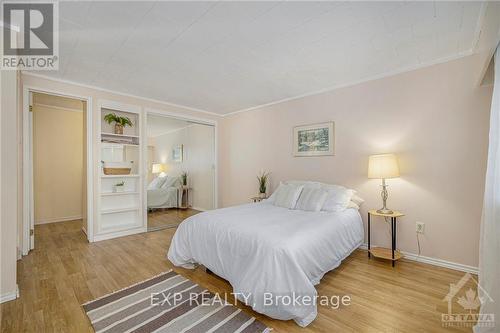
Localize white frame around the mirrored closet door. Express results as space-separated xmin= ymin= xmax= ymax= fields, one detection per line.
xmin=142 ymin=108 xmax=219 ymax=223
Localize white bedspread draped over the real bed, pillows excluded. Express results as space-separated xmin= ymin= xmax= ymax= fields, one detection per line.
xmin=168 ymin=202 xmax=364 ymax=326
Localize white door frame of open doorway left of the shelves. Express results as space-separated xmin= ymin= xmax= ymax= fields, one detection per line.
xmin=22 ymin=84 xmax=94 ymax=255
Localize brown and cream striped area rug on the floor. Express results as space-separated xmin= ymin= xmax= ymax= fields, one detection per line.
xmin=83 ymin=270 xmax=271 ymax=333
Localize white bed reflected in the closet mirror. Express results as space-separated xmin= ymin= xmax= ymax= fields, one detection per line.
xmin=147 ymin=176 xmax=180 ymax=209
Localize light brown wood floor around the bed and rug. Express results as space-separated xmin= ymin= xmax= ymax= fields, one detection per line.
xmin=0 ymin=221 xmax=471 ymax=332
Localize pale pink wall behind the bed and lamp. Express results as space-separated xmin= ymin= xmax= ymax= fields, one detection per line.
xmin=219 ymin=56 xmax=492 ymax=267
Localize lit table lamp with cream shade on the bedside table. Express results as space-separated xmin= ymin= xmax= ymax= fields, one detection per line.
xmin=368 ymin=154 xmax=399 ymax=214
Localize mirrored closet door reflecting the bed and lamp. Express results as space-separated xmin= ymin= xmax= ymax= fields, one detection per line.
xmin=146 ymin=113 xmax=215 ymax=231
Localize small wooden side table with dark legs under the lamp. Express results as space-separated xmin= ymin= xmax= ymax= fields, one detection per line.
xmin=368 ymin=210 xmax=404 ymax=267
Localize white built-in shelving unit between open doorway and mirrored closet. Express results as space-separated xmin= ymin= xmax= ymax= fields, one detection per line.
xmin=94 ymin=101 xmax=146 ymax=240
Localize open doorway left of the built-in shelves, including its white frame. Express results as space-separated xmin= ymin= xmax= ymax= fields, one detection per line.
xmin=23 ymin=88 xmax=92 ymax=255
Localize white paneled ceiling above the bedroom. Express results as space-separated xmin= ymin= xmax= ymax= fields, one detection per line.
xmin=39 ymin=1 xmax=482 ymax=114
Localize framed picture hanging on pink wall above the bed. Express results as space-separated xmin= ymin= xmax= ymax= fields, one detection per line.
xmin=293 ymin=121 xmax=335 ymax=157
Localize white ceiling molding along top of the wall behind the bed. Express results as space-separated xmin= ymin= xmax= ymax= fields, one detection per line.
xmin=223 ymin=49 xmax=473 ymax=117
